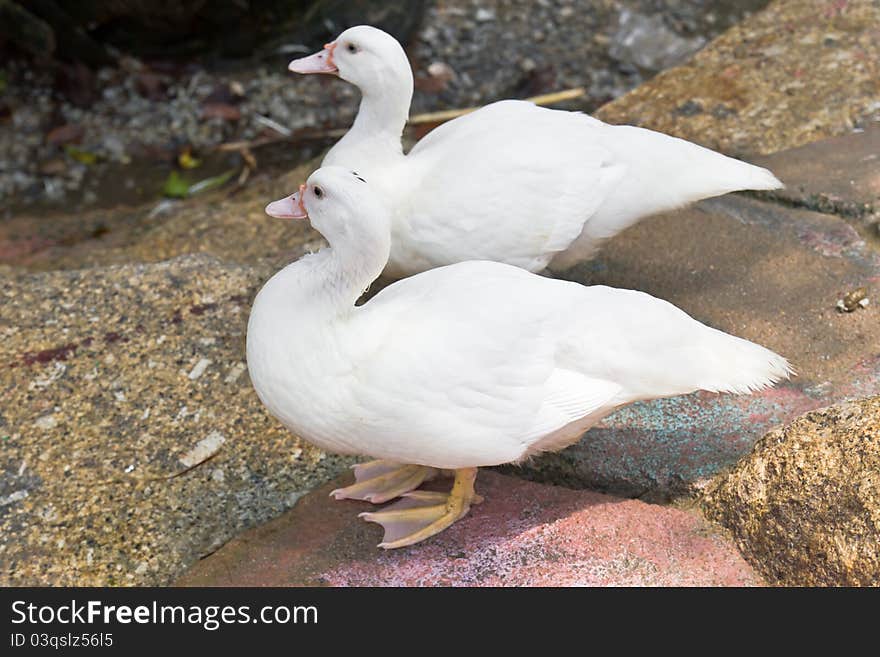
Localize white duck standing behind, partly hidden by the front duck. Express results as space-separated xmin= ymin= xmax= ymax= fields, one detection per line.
xmin=290 ymin=26 xmax=782 ymax=277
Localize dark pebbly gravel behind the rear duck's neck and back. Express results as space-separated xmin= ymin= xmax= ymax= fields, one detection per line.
xmin=0 ymin=0 xmax=766 ymax=210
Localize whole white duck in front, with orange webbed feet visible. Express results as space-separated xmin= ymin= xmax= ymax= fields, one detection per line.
xmin=247 ymin=167 xmax=790 ymax=548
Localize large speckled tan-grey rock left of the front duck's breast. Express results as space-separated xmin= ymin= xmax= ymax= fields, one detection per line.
xmin=0 ymin=256 xmax=344 ymax=585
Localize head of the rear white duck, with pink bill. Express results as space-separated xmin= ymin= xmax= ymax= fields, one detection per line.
xmin=288 ymin=25 xmax=413 ymax=100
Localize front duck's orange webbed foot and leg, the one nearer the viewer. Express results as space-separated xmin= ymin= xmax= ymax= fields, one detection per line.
xmin=359 ymin=468 xmax=482 ymax=550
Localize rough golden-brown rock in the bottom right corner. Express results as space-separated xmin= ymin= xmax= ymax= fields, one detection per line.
xmin=703 ymin=397 xmax=880 ymax=586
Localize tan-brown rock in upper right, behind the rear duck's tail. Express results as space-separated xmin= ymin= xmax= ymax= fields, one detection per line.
xmin=598 ymin=0 xmax=880 ymax=154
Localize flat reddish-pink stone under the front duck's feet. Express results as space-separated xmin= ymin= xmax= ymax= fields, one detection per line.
xmin=177 ymin=472 xmax=761 ymax=586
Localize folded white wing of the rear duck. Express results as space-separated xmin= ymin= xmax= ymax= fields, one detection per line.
xmin=392 ymin=101 xmax=625 ymax=271
